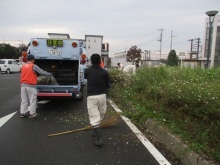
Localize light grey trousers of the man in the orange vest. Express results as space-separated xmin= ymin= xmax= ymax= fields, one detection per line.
xmin=20 ymin=86 xmax=37 ymax=115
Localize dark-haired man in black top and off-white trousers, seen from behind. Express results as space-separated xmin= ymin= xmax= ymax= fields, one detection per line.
xmin=85 ymin=54 xmax=110 ymax=146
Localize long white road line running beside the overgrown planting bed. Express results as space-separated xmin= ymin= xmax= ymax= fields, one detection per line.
xmin=108 ymin=99 xmax=171 ymax=165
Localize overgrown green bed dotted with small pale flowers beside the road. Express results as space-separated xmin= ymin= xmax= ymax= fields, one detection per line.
xmin=109 ymin=67 xmax=220 ymax=161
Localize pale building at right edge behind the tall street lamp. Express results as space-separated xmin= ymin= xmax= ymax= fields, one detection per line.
xmin=202 ymin=15 xmax=220 ymax=67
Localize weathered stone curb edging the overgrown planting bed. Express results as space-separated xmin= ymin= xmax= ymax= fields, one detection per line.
xmin=144 ymin=119 xmax=217 ymax=165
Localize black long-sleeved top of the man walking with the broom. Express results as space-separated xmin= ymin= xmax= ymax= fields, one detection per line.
xmin=85 ymin=65 xmax=110 ymax=96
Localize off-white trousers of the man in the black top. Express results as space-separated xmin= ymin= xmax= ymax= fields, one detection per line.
xmin=87 ymin=94 xmax=107 ymax=127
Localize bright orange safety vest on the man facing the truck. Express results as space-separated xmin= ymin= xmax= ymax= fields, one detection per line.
xmin=21 ymin=63 xmax=37 ymax=85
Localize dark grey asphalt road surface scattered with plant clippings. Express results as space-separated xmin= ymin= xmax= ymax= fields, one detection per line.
xmin=0 ymin=73 xmax=162 ymax=165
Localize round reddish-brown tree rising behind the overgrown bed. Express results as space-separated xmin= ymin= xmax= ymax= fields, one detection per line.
xmin=126 ymin=45 xmax=141 ymax=64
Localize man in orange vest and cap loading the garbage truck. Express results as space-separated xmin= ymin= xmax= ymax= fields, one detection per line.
xmin=20 ymin=55 xmax=52 ymax=118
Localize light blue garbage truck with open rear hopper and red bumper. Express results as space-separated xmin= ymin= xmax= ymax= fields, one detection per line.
xmin=27 ymin=33 xmax=87 ymax=100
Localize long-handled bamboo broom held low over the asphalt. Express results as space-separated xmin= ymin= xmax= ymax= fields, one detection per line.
xmin=48 ymin=115 xmax=119 ymax=137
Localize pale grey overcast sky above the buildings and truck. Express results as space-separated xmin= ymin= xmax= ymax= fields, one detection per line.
xmin=0 ymin=0 xmax=220 ymax=55
